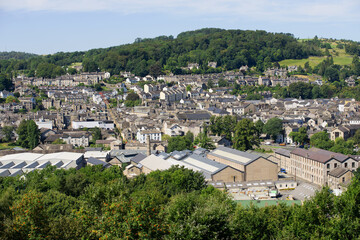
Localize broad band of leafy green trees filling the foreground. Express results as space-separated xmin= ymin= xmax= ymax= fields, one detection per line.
xmin=0 ymin=166 xmax=360 ymax=240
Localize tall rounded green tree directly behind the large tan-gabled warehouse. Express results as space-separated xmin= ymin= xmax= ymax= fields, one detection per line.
xmin=233 ymin=118 xmax=260 ymax=151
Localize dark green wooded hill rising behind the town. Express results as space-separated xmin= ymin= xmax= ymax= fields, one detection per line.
xmin=0 ymin=29 xmax=322 ymax=77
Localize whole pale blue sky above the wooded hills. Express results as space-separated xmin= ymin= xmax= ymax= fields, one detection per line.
xmin=0 ymin=0 xmax=360 ymax=54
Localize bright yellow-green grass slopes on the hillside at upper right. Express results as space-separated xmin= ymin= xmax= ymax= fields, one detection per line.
xmin=279 ymin=39 xmax=353 ymax=67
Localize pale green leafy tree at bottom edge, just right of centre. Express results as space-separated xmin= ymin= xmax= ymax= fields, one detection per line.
xmin=165 ymin=187 xmax=235 ymax=239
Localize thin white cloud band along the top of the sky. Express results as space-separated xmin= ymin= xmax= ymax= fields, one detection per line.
xmin=0 ymin=0 xmax=360 ymax=22
